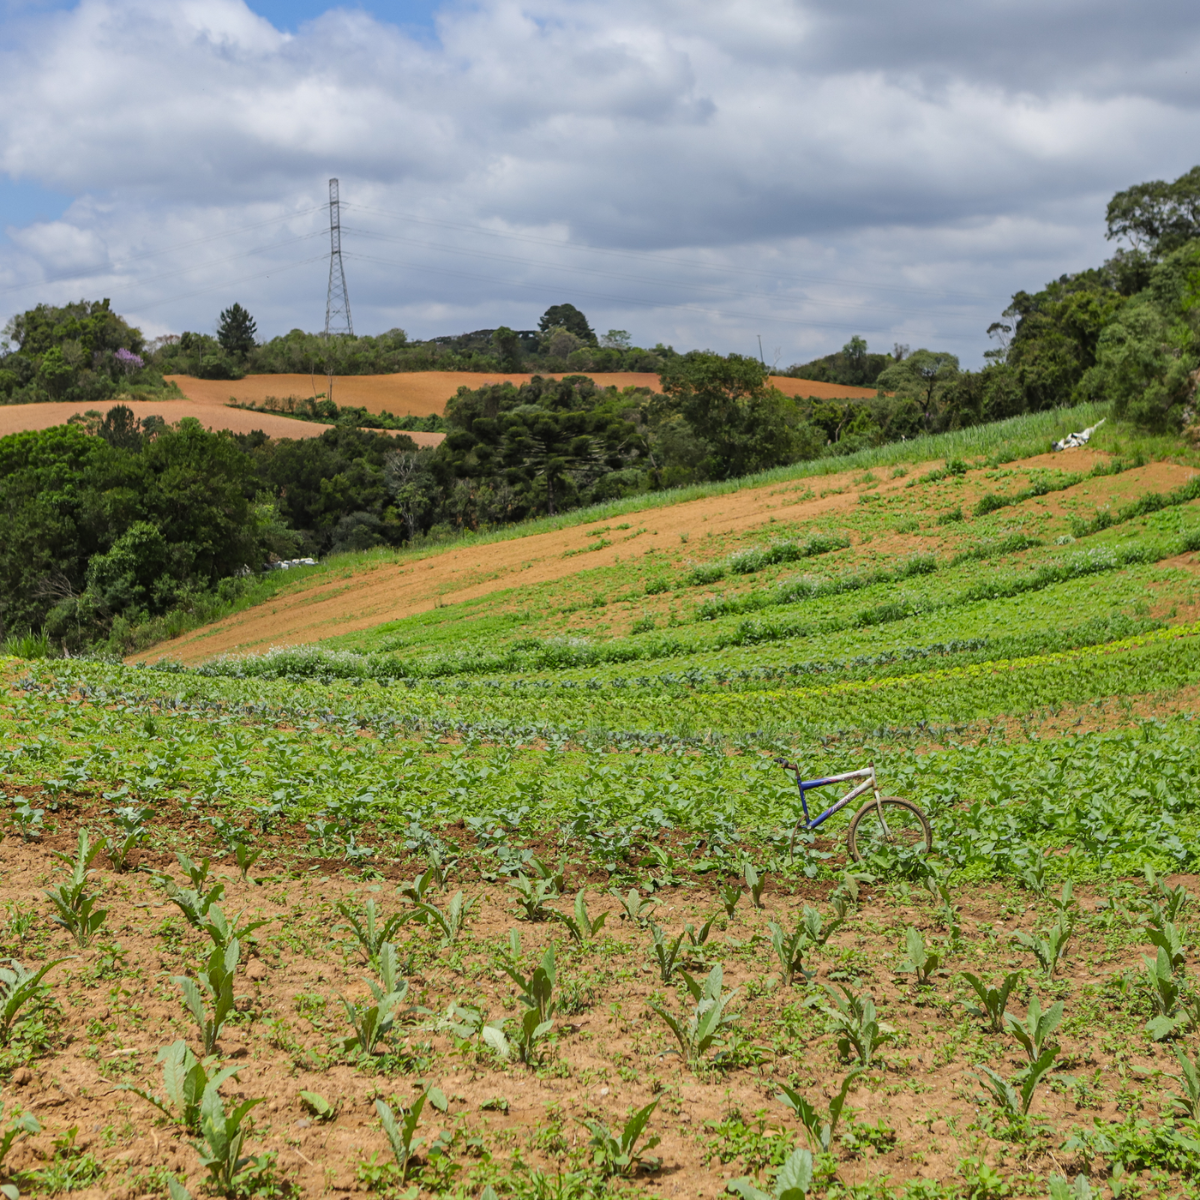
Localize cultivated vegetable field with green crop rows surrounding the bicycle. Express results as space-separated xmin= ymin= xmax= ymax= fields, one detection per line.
xmin=0 ymin=414 xmax=1200 ymax=1200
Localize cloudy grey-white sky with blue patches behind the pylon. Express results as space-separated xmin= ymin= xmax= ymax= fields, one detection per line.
xmin=0 ymin=0 xmax=1200 ymax=367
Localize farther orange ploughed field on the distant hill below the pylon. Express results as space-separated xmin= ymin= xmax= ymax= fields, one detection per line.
xmin=167 ymin=371 xmax=875 ymax=417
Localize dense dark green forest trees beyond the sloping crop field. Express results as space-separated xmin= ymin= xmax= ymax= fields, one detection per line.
xmin=0 ymin=168 xmax=1200 ymax=652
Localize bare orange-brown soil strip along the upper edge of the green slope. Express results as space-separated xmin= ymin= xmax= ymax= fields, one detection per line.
xmin=134 ymin=450 xmax=1189 ymax=662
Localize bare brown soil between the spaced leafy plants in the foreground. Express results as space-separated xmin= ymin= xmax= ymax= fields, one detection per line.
xmin=0 ymin=787 xmax=1171 ymax=1200
